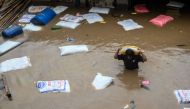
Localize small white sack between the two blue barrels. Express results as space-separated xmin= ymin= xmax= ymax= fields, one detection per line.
xmin=23 ymin=23 xmax=42 ymax=31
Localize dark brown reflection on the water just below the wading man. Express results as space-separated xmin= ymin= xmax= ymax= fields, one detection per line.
xmin=116 ymin=69 xmax=144 ymax=90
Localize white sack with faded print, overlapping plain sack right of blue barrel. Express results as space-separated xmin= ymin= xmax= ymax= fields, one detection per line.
xmin=60 ymin=14 xmax=84 ymax=23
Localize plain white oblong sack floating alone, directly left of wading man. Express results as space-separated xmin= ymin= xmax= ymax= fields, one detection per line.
xmin=59 ymin=45 xmax=88 ymax=56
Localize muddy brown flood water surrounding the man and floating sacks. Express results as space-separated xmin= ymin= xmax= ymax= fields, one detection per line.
xmin=0 ymin=9 xmax=190 ymax=109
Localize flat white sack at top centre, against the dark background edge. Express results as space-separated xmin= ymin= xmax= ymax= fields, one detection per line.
xmin=89 ymin=7 xmax=110 ymax=14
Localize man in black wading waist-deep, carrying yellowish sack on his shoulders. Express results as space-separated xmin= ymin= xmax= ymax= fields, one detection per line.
xmin=114 ymin=46 xmax=147 ymax=70
